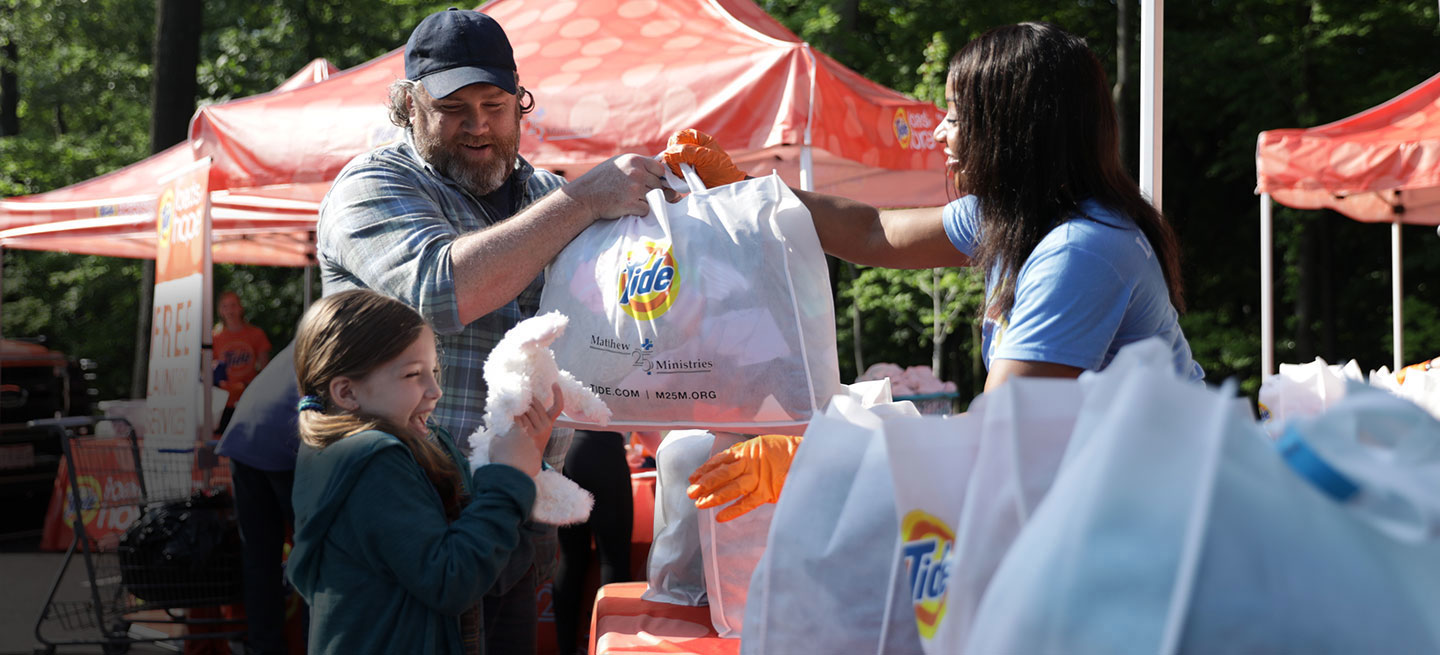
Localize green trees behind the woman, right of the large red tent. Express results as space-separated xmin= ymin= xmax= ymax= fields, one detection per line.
xmin=762 ymin=0 xmax=1440 ymax=394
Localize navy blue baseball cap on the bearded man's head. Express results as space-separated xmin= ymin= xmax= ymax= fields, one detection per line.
xmin=405 ymin=7 xmax=516 ymax=98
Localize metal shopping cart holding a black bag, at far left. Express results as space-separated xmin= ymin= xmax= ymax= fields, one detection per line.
xmin=30 ymin=416 xmax=243 ymax=654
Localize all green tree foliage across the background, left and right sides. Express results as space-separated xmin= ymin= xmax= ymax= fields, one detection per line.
xmin=0 ymin=0 xmax=1440 ymax=397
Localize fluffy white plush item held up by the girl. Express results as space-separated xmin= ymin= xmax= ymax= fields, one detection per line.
xmin=469 ymin=311 xmax=611 ymax=525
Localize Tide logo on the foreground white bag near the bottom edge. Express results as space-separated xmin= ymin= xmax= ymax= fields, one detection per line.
xmin=900 ymin=510 xmax=955 ymax=639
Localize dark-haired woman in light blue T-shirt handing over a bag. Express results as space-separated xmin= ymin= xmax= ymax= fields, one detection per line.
xmin=665 ymin=23 xmax=1204 ymax=390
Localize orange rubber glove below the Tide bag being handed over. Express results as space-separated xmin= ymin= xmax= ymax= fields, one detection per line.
xmin=685 ymin=435 xmax=801 ymax=523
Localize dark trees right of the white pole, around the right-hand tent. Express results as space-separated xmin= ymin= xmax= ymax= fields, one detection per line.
xmin=1164 ymin=0 xmax=1440 ymax=392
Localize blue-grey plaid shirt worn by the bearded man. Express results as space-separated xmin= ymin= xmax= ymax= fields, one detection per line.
xmin=315 ymin=130 xmax=573 ymax=469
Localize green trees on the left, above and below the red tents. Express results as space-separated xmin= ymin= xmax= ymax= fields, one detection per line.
xmin=0 ymin=0 xmax=449 ymax=399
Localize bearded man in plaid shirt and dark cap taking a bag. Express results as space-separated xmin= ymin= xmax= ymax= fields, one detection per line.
xmin=315 ymin=9 xmax=664 ymax=654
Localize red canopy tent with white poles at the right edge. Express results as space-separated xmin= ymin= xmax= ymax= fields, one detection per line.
xmin=1256 ymin=75 xmax=1440 ymax=376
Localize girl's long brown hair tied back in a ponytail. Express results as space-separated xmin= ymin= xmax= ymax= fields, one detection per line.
xmin=295 ymin=289 xmax=462 ymax=520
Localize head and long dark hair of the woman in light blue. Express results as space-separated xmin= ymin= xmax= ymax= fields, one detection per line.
xmin=948 ymin=23 xmax=1185 ymax=321
